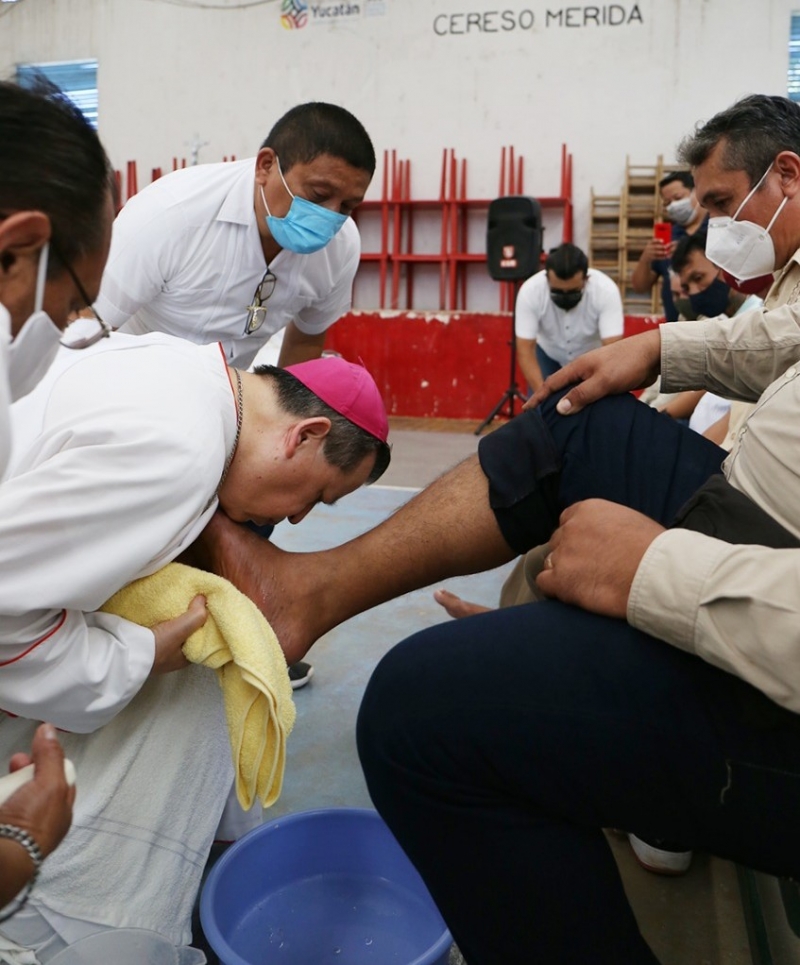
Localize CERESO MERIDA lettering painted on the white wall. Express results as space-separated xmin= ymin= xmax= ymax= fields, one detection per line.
xmin=433 ymin=3 xmax=644 ymax=37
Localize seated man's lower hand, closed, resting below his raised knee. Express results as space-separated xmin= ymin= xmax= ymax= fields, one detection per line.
xmin=536 ymin=499 xmax=664 ymax=620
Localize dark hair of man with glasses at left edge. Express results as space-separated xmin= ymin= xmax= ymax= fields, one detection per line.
xmin=0 ymin=77 xmax=114 ymax=276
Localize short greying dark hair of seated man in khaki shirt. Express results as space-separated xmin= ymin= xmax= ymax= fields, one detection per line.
xmin=678 ymin=94 xmax=800 ymax=185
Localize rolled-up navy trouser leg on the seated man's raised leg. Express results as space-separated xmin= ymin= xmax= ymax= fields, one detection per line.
xmin=478 ymin=393 xmax=726 ymax=553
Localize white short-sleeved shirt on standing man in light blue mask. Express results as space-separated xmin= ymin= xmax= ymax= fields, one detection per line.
xmin=91 ymin=158 xmax=361 ymax=367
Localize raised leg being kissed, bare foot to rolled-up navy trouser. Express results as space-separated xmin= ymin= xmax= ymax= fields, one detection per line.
xmin=198 ymin=395 xmax=725 ymax=662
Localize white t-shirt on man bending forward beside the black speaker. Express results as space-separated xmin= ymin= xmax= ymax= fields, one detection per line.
xmin=514 ymin=268 xmax=624 ymax=365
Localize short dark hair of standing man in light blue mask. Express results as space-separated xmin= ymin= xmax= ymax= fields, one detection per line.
xmin=261 ymin=101 xmax=375 ymax=176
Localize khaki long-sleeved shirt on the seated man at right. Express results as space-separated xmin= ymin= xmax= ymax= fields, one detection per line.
xmin=628 ymin=250 xmax=800 ymax=712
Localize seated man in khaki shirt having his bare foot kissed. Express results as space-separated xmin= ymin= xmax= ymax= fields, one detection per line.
xmin=194 ymin=95 xmax=800 ymax=965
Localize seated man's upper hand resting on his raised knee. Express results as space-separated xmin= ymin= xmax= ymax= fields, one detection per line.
xmin=522 ymin=329 xmax=661 ymax=415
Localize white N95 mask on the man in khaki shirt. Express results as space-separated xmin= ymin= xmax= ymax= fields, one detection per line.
xmin=706 ymin=163 xmax=789 ymax=281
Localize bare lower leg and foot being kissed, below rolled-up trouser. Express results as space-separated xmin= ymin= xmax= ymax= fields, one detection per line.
xmin=198 ymin=456 xmax=515 ymax=663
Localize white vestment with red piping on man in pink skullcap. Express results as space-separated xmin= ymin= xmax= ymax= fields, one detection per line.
xmin=0 ymin=334 xmax=241 ymax=944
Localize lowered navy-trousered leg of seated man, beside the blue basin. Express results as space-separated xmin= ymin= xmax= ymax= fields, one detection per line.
xmin=358 ymin=601 xmax=800 ymax=965
